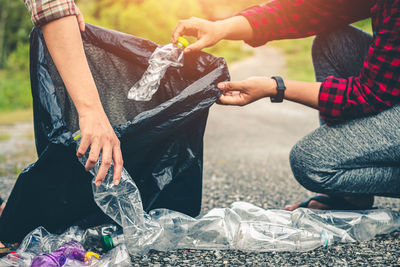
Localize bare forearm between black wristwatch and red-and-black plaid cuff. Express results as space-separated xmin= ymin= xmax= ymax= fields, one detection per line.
xmin=285 ymin=81 xmax=321 ymax=109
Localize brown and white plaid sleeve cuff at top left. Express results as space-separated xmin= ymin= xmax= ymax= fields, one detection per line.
xmin=24 ymin=0 xmax=79 ymax=26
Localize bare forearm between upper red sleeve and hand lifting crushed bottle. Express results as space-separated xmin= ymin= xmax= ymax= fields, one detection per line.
xmin=215 ymin=16 xmax=253 ymax=41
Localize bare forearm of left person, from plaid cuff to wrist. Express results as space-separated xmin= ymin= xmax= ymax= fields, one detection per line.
xmin=42 ymin=16 xmax=103 ymax=116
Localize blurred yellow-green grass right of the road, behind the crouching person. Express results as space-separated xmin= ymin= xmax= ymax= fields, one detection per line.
xmin=271 ymin=19 xmax=372 ymax=81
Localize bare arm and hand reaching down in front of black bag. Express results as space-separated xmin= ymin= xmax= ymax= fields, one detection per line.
xmin=42 ymin=16 xmax=123 ymax=185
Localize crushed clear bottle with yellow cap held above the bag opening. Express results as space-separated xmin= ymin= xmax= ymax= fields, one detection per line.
xmin=128 ymin=37 xmax=187 ymax=101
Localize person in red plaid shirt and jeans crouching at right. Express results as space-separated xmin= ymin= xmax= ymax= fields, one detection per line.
xmin=172 ymin=0 xmax=400 ymax=210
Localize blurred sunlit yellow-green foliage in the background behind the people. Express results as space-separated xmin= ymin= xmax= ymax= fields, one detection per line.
xmin=0 ymin=0 xmax=376 ymax=113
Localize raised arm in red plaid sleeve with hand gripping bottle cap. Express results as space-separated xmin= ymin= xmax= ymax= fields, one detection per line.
xmin=172 ymin=0 xmax=376 ymax=52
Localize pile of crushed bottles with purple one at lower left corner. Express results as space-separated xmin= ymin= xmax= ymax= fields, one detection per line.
xmin=0 ymin=225 xmax=131 ymax=267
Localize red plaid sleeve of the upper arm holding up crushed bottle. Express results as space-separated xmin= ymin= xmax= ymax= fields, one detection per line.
xmin=238 ymin=0 xmax=374 ymax=46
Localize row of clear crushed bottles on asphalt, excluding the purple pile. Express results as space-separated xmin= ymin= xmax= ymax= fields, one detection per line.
xmin=72 ymin=137 xmax=400 ymax=255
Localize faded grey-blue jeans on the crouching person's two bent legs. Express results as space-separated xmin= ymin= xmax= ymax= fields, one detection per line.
xmin=290 ymin=26 xmax=400 ymax=197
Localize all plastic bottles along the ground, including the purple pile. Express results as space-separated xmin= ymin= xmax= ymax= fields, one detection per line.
xmin=0 ymin=155 xmax=400 ymax=267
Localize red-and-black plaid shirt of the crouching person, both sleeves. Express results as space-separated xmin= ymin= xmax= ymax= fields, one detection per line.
xmin=240 ymin=0 xmax=400 ymax=123
